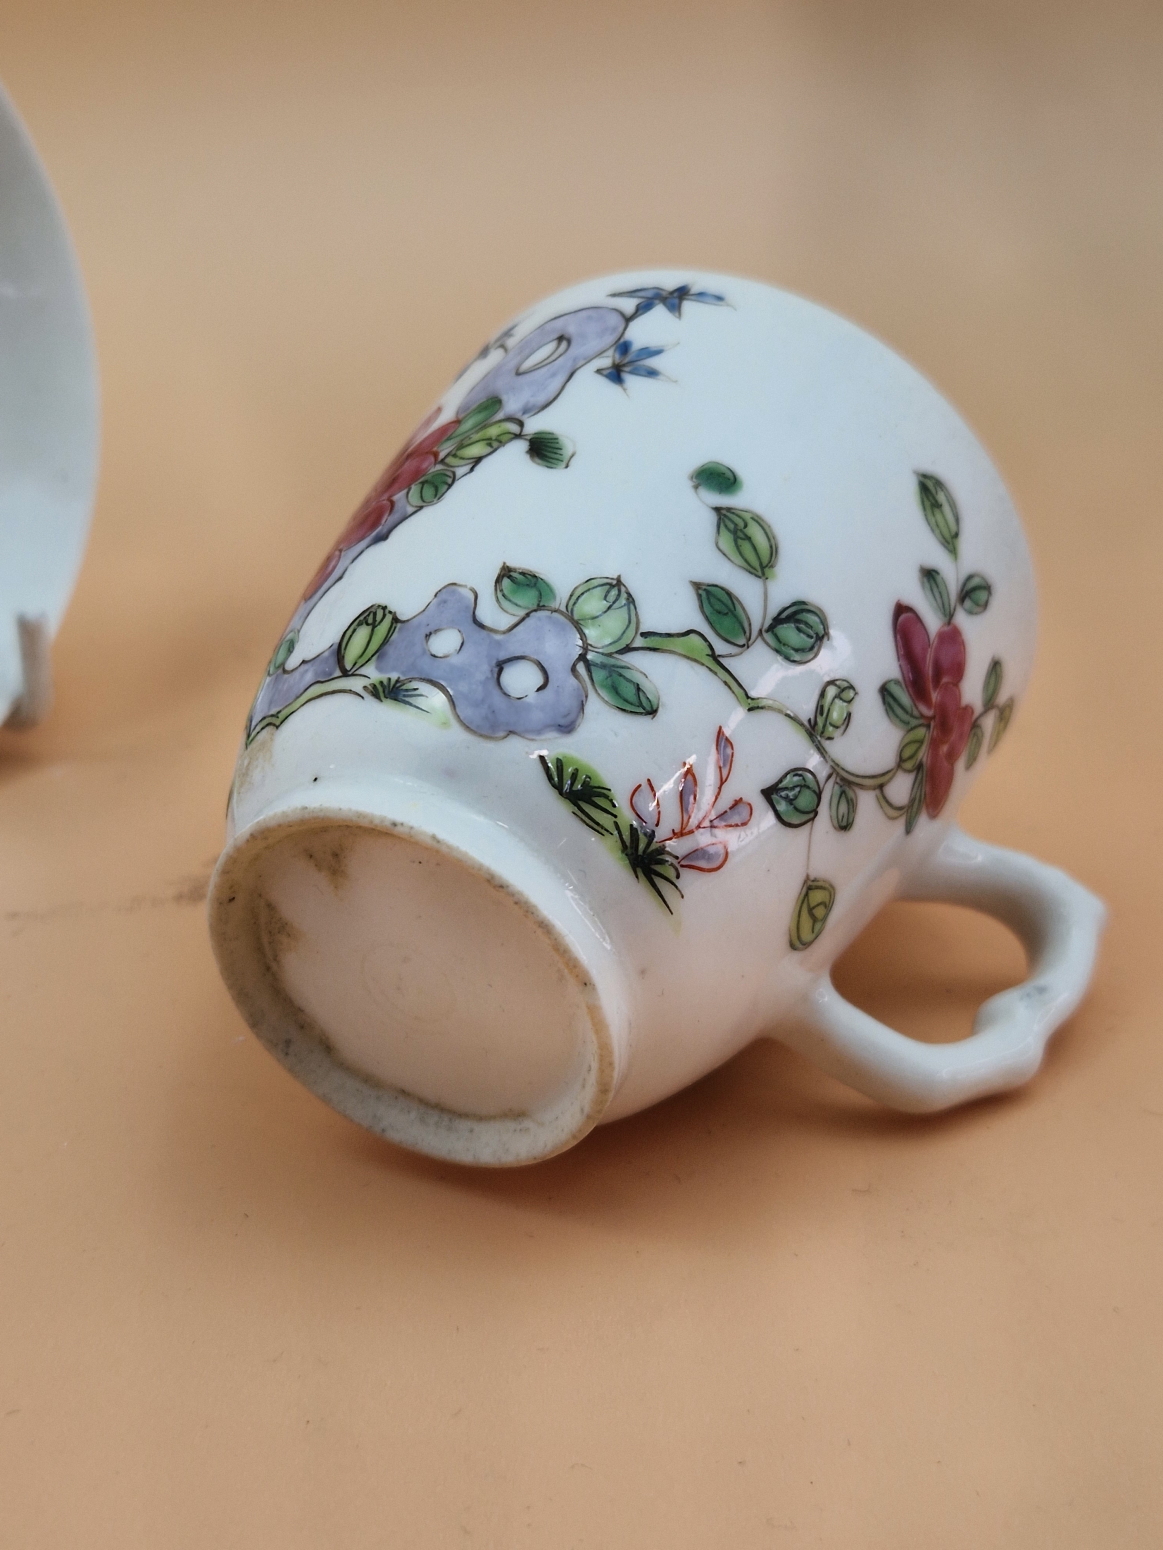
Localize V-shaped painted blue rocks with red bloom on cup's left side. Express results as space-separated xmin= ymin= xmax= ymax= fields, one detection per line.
xmin=247 ymin=284 xmax=726 ymax=742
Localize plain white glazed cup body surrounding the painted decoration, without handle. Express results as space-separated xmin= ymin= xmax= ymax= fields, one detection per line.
xmin=216 ymin=271 xmax=1073 ymax=1159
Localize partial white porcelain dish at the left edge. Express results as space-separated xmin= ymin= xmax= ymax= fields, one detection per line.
xmin=0 ymin=88 xmax=98 ymax=721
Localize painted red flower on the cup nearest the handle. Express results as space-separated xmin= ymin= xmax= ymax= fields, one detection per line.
xmin=893 ymin=603 xmax=974 ymax=818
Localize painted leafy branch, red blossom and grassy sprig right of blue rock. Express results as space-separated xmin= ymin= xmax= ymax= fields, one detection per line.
xmin=542 ymin=462 xmax=1014 ymax=950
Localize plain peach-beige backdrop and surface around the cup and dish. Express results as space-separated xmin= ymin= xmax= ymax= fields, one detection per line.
xmin=0 ymin=0 xmax=1163 ymax=1550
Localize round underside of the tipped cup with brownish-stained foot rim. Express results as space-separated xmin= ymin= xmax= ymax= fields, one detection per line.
xmin=209 ymin=803 xmax=625 ymax=1164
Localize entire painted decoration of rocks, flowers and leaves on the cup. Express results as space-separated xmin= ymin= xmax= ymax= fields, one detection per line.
xmin=247 ymin=285 xmax=1014 ymax=949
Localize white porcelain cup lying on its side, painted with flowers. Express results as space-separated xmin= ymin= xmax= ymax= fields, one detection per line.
xmin=211 ymin=271 xmax=1104 ymax=1164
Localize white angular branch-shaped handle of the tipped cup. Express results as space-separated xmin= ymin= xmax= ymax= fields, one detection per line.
xmin=777 ymin=828 xmax=1107 ymax=1113
